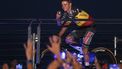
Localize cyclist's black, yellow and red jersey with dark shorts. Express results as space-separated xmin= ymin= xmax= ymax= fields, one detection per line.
xmin=57 ymin=9 xmax=95 ymax=45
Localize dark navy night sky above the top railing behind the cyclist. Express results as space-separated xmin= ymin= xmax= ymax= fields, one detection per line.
xmin=0 ymin=0 xmax=122 ymax=19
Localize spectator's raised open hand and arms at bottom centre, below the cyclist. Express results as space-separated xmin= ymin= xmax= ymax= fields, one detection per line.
xmin=48 ymin=35 xmax=81 ymax=69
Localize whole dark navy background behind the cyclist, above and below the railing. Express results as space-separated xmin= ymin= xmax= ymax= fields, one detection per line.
xmin=0 ymin=0 xmax=122 ymax=67
